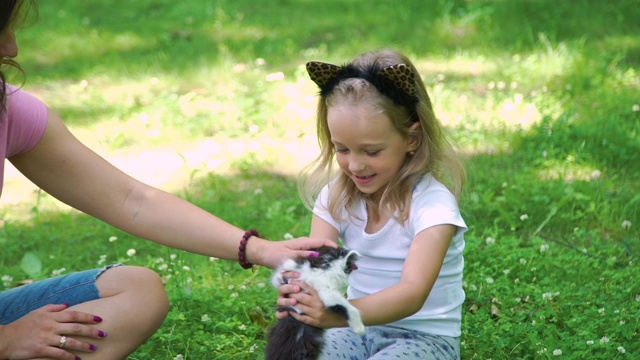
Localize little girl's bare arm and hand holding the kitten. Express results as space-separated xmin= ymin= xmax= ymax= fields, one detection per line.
xmin=285 ymin=225 xmax=456 ymax=328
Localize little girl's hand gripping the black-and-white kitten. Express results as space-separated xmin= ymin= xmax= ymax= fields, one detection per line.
xmin=276 ymin=280 xmax=348 ymax=329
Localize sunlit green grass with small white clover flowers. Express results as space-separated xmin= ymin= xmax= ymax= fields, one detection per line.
xmin=0 ymin=0 xmax=640 ymax=359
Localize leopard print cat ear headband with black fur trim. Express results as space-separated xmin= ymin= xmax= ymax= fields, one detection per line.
xmin=307 ymin=61 xmax=419 ymax=118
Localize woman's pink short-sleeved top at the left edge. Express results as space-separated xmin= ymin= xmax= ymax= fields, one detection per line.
xmin=0 ymin=84 xmax=48 ymax=195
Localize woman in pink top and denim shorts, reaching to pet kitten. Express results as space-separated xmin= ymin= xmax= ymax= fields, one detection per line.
xmin=0 ymin=0 xmax=331 ymax=360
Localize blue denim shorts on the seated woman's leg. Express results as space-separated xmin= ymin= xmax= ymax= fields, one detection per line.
xmin=0 ymin=264 xmax=121 ymax=325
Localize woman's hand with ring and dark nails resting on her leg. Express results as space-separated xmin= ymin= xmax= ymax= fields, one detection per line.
xmin=0 ymin=304 xmax=107 ymax=360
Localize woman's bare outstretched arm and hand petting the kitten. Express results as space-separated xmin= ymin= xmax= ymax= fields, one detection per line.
xmin=10 ymin=111 xmax=330 ymax=267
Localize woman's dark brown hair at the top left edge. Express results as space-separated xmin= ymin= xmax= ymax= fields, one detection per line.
xmin=0 ymin=0 xmax=35 ymax=112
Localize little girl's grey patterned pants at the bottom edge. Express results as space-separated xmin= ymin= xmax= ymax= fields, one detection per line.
xmin=320 ymin=326 xmax=460 ymax=360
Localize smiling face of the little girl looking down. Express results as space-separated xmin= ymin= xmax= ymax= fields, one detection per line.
xmin=327 ymin=102 xmax=415 ymax=200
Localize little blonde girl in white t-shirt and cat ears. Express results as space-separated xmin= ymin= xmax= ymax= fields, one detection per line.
xmin=278 ymin=50 xmax=466 ymax=359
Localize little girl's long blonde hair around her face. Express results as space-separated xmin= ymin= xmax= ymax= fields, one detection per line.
xmin=298 ymin=50 xmax=465 ymax=222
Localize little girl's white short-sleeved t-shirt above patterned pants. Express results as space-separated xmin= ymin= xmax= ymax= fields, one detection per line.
xmin=313 ymin=175 xmax=467 ymax=337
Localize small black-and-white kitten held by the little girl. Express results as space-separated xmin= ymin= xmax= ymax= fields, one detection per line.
xmin=265 ymin=246 xmax=364 ymax=360
